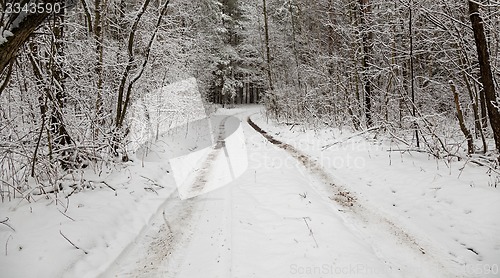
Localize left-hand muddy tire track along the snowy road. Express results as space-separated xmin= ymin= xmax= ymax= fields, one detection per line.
xmin=100 ymin=115 xmax=232 ymax=277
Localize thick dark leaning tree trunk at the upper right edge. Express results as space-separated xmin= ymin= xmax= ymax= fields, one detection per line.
xmin=469 ymin=1 xmax=500 ymax=154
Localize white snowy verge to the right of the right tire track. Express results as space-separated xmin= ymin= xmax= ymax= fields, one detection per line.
xmin=251 ymin=109 xmax=500 ymax=277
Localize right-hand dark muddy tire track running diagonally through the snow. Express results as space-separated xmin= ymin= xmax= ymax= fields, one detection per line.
xmin=247 ymin=116 xmax=455 ymax=277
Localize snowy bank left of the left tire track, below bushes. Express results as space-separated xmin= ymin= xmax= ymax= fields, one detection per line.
xmin=0 ymin=161 xmax=175 ymax=277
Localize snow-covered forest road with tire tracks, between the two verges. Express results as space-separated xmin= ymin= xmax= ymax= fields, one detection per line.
xmin=99 ymin=109 xmax=457 ymax=277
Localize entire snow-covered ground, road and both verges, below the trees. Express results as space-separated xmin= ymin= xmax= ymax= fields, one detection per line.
xmin=0 ymin=106 xmax=500 ymax=277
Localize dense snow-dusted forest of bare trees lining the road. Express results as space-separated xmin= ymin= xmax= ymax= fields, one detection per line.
xmin=0 ymin=0 xmax=500 ymax=200
